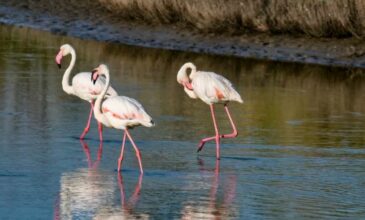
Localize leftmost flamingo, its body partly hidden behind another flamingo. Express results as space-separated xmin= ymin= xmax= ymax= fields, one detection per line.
xmin=56 ymin=44 xmax=118 ymax=140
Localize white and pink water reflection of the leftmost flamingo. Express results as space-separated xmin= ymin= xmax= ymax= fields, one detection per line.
xmin=54 ymin=140 xmax=116 ymax=219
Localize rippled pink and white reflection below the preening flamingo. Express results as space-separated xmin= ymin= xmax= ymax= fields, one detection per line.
xmin=182 ymin=158 xmax=237 ymax=219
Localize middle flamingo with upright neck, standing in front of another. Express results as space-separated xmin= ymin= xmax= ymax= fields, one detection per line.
xmin=91 ymin=64 xmax=154 ymax=173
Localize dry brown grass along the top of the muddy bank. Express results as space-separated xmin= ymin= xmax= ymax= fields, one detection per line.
xmin=99 ymin=0 xmax=365 ymax=38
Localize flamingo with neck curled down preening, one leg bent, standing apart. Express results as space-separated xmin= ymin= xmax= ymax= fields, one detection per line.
xmin=177 ymin=62 xmax=243 ymax=160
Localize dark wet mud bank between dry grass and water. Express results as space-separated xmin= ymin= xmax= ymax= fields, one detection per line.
xmin=0 ymin=0 xmax=365 ymax=68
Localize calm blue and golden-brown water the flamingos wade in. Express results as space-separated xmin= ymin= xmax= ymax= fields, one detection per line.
xmin=0 ymin=26 xmax=365 ymax=219
